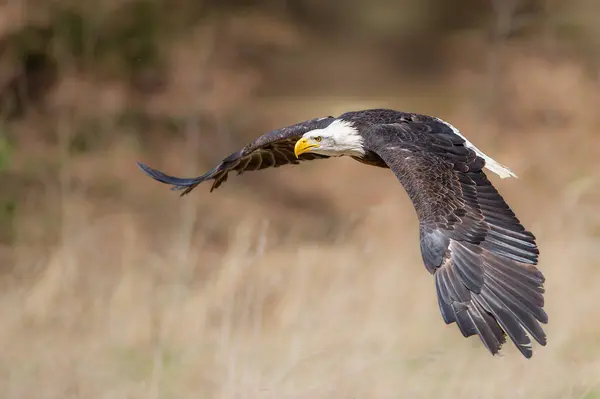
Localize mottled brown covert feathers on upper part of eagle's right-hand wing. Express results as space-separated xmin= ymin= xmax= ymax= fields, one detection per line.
xmin=370 ymin=124 xmax=487 ymax=244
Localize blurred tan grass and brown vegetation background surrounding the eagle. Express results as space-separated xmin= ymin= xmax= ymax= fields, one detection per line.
xmin=0 ymin=0 xmax=600 ymax=399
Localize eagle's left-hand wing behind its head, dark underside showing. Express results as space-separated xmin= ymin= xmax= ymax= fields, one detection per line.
xmin=138 ymin=116 xmax=335 ymax=196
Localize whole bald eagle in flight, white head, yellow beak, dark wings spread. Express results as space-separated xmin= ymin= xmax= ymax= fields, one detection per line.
xmin=138 ymin=109 xmax=548 ymax=358
